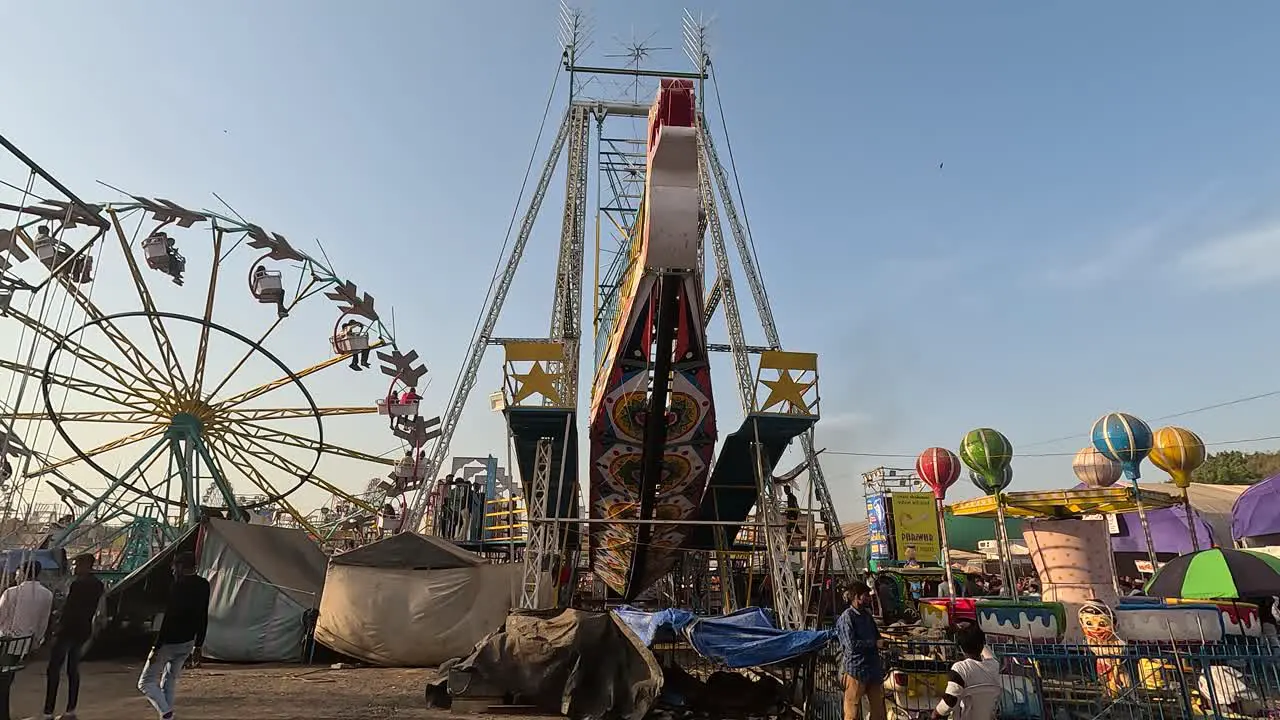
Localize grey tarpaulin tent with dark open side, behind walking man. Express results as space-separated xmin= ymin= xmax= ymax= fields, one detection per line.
xmin=95 ymin=519 xmax=325 ymax=662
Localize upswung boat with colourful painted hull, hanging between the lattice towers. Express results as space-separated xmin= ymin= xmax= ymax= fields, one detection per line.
xmin=590 ymin=78 xmax=716 ymax=600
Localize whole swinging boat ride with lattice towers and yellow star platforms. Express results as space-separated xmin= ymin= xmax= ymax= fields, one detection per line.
xmin=412 ymin=6 xmax=852 ymax=628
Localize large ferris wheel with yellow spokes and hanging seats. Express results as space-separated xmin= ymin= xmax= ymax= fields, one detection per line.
xmin=0 ymin=158 xmax=439 ymax=546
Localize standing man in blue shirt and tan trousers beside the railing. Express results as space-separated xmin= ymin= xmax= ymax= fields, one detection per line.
xmin=836 ymin=582 xmax=886 ymax=720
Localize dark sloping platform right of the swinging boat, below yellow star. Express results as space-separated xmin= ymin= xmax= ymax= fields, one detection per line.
xmin=685 ymin=413 xmax=817 ymax=550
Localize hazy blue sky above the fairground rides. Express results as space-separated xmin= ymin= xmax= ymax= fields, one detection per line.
xmin=0 ymin=0 xmax=1280 ymax=518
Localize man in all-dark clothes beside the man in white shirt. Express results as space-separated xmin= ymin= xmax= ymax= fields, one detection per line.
xmin=45 ymin=553 xmax=105 ymax=719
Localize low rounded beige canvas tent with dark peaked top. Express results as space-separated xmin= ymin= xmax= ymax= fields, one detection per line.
xmin=315 ymin=533 xmax=545 ymax=667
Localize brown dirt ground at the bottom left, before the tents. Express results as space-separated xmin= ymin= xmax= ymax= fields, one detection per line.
xmin=12 ymin=661 xmax=481 ymax=720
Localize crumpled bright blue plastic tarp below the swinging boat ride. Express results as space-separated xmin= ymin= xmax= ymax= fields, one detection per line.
xmin=613 ymin=606 xmax=836 ymax=669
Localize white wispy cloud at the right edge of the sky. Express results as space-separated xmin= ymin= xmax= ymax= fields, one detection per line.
xmin=1175 ymin=220 xmax=1280 ymax=288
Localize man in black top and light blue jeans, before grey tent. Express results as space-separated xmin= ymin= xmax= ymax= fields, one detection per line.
xmin=138 ymin=552 xmax=209 ymax=720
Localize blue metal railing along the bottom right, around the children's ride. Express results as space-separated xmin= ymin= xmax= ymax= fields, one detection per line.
xmin=809 ymin=638 xmax=1280 ymax=720
